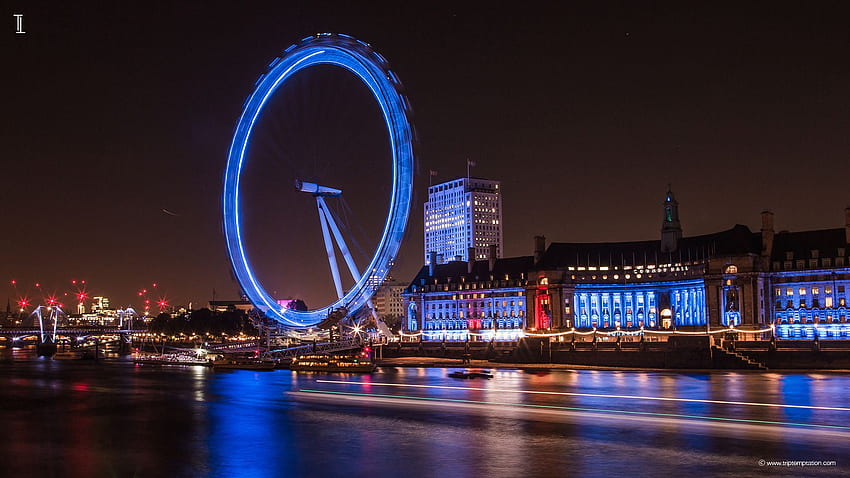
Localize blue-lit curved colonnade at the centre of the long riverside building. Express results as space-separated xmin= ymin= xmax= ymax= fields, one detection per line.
xmin=573 ymin=279 xmax=706 ymax=329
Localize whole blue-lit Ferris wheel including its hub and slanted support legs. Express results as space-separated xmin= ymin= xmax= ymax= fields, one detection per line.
xmin=222 ymin=33 xmax=414 ymax=328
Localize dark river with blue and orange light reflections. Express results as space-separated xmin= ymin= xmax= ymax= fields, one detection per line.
xmin=0 ymin=350 xmax=850 ymax=477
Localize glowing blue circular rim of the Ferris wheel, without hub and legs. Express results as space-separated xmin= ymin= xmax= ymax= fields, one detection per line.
xmin=222 ymin=34 xmax=414 ymax=328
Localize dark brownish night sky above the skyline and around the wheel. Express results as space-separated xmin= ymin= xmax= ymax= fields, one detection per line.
xmin=0 ymin=0 xmax=850 ymax=307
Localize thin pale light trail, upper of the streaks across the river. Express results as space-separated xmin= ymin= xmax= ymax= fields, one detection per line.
xmin=316 ymin=380 xmax=850 ymax=412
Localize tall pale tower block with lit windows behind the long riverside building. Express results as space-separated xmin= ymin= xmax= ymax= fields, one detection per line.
xmin=425 ymin=178 xmax=503 ymax=265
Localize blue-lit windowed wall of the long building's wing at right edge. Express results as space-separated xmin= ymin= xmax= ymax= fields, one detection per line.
xmin=772 ymin=268 xmax=850 ymax=339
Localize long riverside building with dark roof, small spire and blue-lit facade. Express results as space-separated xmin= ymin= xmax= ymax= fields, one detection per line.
xmin=404 ymin=191 xmax=850 ymax=340
